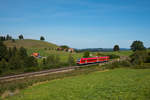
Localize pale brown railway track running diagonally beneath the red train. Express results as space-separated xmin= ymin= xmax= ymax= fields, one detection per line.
xmin=0 ymin=58 xmax=129 ymax=82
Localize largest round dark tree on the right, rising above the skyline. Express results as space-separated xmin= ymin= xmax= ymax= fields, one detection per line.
xmin=130 ymin=41 xmax=145 ymax=52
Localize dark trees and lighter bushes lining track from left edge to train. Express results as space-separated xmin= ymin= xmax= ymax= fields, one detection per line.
xmin=0 ymin=41 xmax=75 ymax=75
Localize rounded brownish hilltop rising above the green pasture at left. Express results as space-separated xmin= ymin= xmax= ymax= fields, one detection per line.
xmin=4 ymin=39 xmax=58 ymax=48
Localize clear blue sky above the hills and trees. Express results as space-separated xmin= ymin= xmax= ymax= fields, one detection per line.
xmin=0 ymin=0 xmax=150 ymax=48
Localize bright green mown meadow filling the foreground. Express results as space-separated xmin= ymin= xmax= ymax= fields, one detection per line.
xmin=5 ymin=68 xmax=150 ymax=100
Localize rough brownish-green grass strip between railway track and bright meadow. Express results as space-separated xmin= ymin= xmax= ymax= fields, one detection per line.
xmin=0 ymin=65 xmax=101 ymax=96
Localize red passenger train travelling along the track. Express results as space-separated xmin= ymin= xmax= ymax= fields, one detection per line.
xmin=77 ymin=56 xmax=109 ymax=65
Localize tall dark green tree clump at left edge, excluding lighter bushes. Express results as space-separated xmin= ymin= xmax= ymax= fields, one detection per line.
xmin=0 ymin=41 xmax=38 ymax=74
